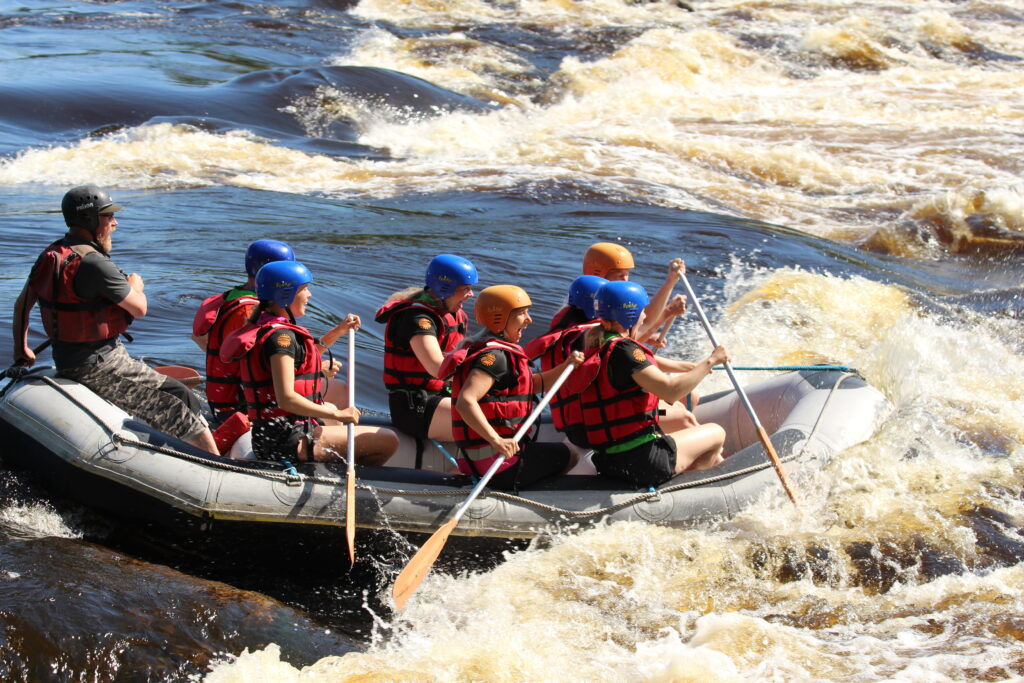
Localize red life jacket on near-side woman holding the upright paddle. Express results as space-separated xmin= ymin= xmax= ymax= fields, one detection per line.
xmin=220 ymin=313 xmax=324 ymax=422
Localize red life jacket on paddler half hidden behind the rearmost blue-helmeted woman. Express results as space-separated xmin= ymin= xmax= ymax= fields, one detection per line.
xmin=193 ymin=287 xmax=259 ymax=413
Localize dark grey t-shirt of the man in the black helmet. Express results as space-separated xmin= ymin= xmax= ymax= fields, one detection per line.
xmin=46 ymin=237 xmax=131 ymax=369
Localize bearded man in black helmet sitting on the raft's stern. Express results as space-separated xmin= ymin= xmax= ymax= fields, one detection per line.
xmin=13 ymin=185 xmax=217 ymax=454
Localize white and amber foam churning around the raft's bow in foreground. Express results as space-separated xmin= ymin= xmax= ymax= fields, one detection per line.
xmin=208 ymin=268 xmax=1024 ymax=681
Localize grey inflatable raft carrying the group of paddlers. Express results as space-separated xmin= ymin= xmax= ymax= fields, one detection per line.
xmin=0 ymin=369 xmax=890 ymax=539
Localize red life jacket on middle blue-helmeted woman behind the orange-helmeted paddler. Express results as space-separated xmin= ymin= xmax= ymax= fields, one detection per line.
xmin=374 ymin=299 xmax=469 ymax=393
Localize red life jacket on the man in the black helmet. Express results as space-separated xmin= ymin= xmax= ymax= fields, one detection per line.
xmin=29 ymin=238 xmax=132 ymax=343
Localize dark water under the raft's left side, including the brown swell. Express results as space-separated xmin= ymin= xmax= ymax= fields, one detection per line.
xmin=0 ymin=458 xmax=525 ymax=680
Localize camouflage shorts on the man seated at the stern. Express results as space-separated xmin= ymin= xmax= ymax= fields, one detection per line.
xmin=59 ymin=344 xmax=208 ymax=441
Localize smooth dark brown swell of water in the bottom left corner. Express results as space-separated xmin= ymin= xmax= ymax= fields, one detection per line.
xmin=0 ymin=528 xmax=356 ymax=680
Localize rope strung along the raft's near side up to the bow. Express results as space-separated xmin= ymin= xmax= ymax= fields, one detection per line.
xmin=29 ymin=366 xmax=859 ymax=519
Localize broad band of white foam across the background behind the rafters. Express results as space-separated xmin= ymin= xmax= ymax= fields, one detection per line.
xmin=0 ymin=3 xmax=1024 ymax=255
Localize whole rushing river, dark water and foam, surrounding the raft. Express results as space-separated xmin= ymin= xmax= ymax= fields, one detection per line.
xmin=0 ymin=0 xmax=1024 ymax=681
